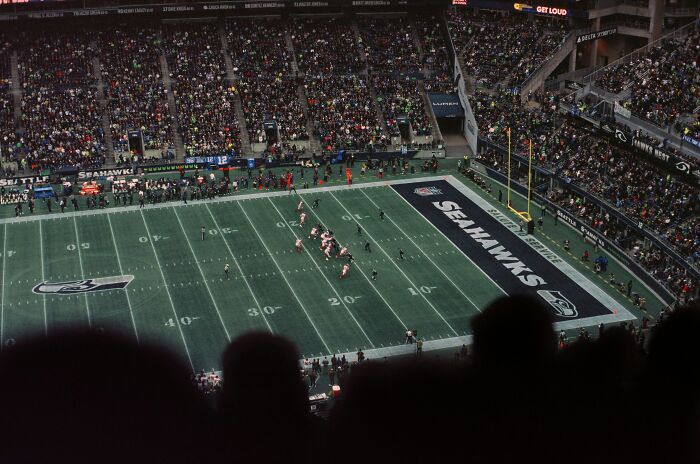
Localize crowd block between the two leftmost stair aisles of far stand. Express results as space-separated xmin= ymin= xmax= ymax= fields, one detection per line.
xmin=18 ymin=30 xmax=105 ymax=169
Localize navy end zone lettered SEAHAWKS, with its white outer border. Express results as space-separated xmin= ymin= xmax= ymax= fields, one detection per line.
xmin=391 ymin=176 xmax=636 ymax=329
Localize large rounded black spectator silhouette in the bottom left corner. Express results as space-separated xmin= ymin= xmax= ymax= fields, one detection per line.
xmin=0 ymin=333 xmax=205 ymax=463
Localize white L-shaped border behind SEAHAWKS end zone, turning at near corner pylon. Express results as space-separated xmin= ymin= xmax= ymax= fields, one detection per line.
xmin=446 ymin=176 xmax=637 ymax=329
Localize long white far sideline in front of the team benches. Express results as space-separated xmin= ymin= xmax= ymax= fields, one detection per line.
xmin=0 ymin=176 xmax=445 ymax=224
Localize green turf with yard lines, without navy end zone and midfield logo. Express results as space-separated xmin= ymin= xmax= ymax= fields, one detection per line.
xmin=0 ymin=163 xmax=664 ymax=370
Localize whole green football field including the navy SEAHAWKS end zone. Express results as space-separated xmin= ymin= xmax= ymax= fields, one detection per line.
xmin=0 ymin=176 xmax=634 ymax=370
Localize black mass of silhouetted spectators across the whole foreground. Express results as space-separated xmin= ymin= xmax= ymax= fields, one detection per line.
xmin=0 ymin=296 xmax=700 ymax=464
